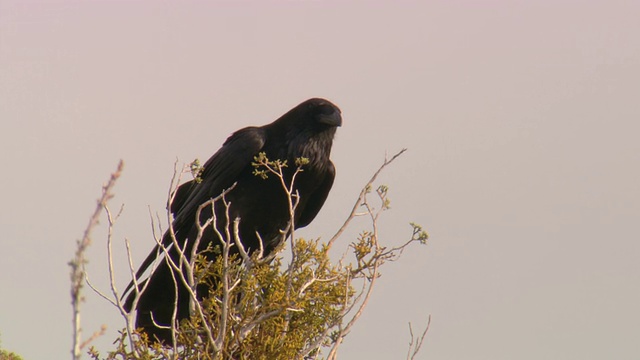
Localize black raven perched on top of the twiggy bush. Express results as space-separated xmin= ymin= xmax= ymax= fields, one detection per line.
xmin=125 ymin=98 xmax=342 ymax=342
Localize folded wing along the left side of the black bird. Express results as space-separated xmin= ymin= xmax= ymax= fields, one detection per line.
xmin=124 ymin=127 xmax=266 ymax=294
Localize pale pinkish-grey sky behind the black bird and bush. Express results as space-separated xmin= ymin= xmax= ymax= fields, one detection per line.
xmin=0 ymin=0 xmax=640 ymax=360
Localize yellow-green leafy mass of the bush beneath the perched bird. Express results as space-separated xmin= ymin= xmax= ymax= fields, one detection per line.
xmin=93 ymin=239 xmax=354 ymax=360
